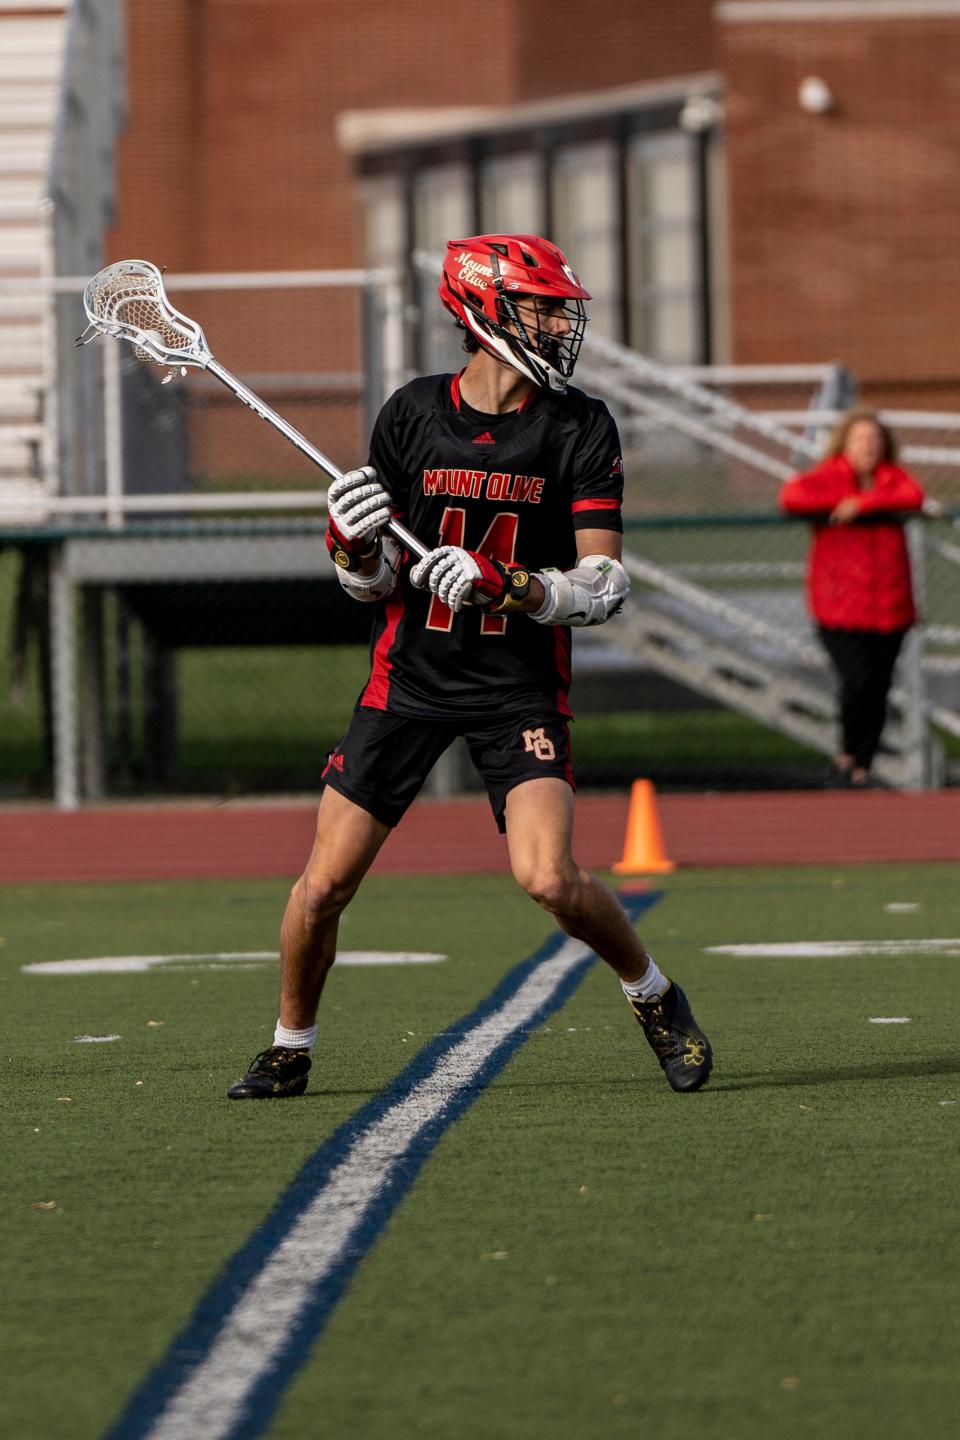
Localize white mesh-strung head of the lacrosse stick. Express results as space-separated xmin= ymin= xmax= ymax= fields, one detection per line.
xmin=76 ymin=261 xmax=212 ymax=370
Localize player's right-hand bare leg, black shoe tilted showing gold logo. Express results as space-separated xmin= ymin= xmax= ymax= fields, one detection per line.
xmin=507 ymin=776 xmax=712 ymax=1090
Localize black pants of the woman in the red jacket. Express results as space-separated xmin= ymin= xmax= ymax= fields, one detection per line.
xmin=820 ymin=625 xmax=907 ymax=770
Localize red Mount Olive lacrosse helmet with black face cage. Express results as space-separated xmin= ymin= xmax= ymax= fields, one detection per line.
xmin=439 ymin=235 xmax=590 ymax=390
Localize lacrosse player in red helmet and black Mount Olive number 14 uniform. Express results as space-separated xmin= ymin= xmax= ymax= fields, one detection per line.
xmin=227 ymin=235 xmax=712 ymax=1099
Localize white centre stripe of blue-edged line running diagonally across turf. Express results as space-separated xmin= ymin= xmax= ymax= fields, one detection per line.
xmin=145 ymin=940 xmax=590 ymax=1440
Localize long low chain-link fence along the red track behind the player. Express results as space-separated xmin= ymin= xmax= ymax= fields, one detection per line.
xmin=0 ymin=521 xmax=960 ymax=804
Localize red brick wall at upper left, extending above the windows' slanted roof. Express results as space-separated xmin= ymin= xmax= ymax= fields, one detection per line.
xmin=109 ymin=0 xmax=712 ymax=269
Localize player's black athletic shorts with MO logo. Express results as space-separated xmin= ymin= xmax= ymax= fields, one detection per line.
xmin=322 ymin=706 xmax=576 ymax=834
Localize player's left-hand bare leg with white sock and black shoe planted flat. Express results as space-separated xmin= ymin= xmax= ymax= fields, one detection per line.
xmin=227 ymin=788 xmax=390 ymax=1100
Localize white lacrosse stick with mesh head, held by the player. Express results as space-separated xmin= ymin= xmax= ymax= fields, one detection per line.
xmin=76 ymin=261 xmax=429 ymax=560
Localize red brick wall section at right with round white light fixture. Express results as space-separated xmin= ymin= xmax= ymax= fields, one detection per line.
xmin=718 ymin=14 xmax=960 ymax=391
